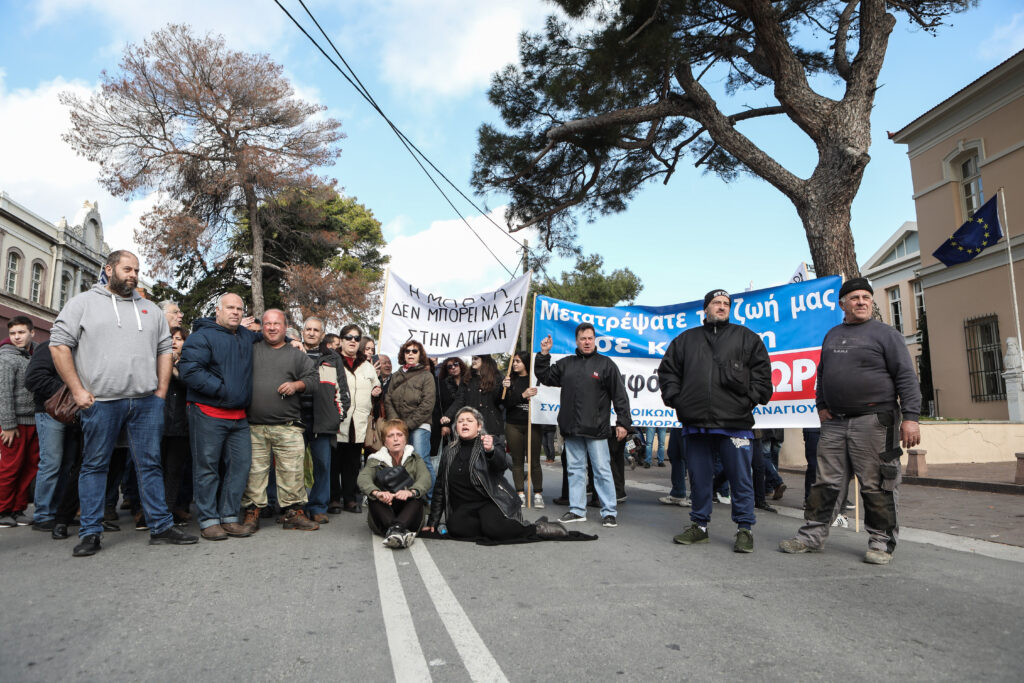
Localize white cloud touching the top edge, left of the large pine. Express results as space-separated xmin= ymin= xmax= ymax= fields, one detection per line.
xmin=378 ymin=0 xmax=553 ymax=96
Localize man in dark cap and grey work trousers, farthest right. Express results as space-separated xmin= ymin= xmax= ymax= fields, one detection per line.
xmin=779 ymin=278 xmax=921 ymax=564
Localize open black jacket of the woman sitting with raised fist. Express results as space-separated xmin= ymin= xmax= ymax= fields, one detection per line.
xmin=427 ymin=436 xmax=527 ymax=526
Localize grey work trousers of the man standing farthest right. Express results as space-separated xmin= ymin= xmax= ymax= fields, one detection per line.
xmin=797 ymin=414 xmax=902 ymax=553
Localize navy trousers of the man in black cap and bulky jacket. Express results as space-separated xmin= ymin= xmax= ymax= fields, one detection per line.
xmin=684 ymin=434 xmax=757 ymax=528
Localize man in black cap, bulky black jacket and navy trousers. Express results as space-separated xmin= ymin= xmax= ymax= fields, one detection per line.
xmin=657 ymin=290 xmax=772 ymax=553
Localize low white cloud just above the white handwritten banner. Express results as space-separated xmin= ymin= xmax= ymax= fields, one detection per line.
xmin=384 ymin=207 xmax=536 ymax=297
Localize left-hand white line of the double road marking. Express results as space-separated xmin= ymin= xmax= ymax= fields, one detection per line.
xmin=370 ymin=535 xmax=431 ymax=683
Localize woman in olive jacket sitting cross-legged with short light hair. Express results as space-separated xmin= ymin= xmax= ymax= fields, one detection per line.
xmin=358 ymin=420 xmax=430 ymax=548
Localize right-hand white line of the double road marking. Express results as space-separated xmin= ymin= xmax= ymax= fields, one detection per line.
xmin=409 ymin=542 xmax=508 ymax=683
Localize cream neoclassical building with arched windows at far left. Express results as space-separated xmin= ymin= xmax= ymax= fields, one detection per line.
xmin=0 ymin=191 xmax=111 ymax=341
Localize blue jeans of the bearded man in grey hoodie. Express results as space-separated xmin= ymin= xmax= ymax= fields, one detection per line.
xmin=78 ymin=394 xmax=174 ymax=537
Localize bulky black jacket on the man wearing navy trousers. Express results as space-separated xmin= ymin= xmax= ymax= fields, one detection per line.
xmin=657 ymin=321 xmax=772 ymax=430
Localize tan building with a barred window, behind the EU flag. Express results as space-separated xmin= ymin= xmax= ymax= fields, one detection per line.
xmin=891 ymin=51 xmax=1024 ymax=420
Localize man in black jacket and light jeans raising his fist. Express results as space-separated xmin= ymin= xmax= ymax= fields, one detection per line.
xmin=534 ymin=323 xmax=633 ymax=526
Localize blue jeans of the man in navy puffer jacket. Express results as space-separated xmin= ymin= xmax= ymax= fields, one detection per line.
xmin=188 ymin=405 xmax=253 ymax=529
